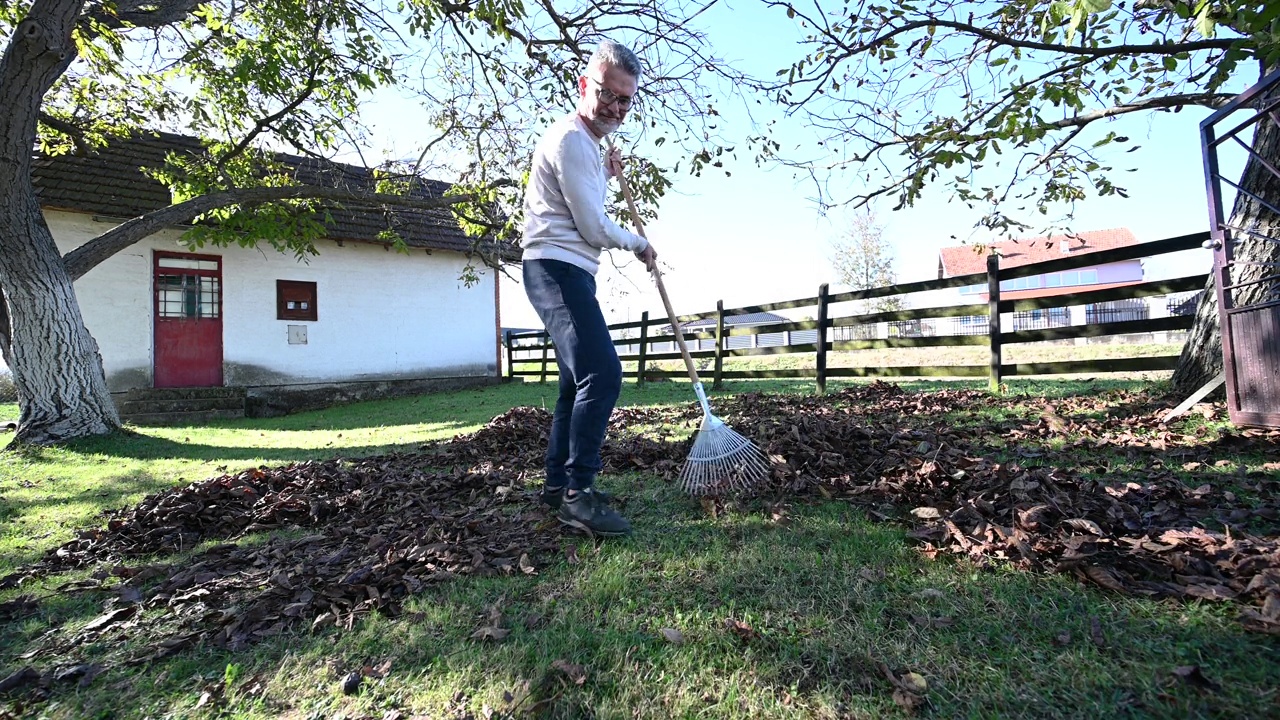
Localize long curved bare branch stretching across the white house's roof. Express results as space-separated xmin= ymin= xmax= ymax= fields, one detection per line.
xmin=63 ymin=179 xmax=516 ymax=279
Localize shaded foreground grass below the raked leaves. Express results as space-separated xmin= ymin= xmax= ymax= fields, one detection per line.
xmin=0 ymin=477 xmax=1280 ymax=719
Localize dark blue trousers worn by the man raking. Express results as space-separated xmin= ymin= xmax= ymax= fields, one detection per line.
xmin=524 ymin=260 xmax=622 ymax=489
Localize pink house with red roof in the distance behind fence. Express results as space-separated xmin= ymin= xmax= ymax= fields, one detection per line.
xmin=938 ymin=228 xmax=1147 ymax=334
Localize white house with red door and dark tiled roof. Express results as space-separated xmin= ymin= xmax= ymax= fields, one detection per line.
xmin=12 ymin=135 xmax=502 ymax=407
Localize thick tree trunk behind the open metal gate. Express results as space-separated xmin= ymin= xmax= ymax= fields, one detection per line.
xmin=1174 ymin=68 xmax=1280 ymax=395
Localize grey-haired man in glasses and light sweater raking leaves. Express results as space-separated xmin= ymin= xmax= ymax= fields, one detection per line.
xmin=521 ymin=40 xmax=658 ymax=536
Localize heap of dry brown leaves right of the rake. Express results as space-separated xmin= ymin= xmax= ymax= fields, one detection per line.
xmin=731 ymin=383 xmax=1280 ymax=633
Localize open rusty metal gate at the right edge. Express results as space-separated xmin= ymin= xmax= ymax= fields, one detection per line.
xmin=1201 ymin=65 xmax=1280 ymax=428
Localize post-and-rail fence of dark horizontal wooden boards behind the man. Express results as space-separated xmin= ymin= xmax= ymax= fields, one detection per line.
xmin=503 ymin=233 xmax=1208 ymax=386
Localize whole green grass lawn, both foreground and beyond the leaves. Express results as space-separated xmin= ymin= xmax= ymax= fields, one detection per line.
xmin=0 ymin=380 xmax=1280 ymax=720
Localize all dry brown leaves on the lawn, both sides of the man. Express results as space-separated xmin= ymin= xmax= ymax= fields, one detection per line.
xmin=0 ymin=383 xmax=1280 ymax=674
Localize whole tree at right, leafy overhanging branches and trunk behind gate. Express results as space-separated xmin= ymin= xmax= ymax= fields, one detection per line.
xmin=758 ymin=0 xmax=1280 ymax=391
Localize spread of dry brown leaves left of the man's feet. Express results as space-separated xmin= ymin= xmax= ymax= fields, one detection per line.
xmin=0 ymin=455 xmax=559 ymax=661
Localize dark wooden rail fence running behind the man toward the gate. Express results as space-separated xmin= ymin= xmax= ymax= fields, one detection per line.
xmin=503 ymin=232 xmax=1208 ymax=391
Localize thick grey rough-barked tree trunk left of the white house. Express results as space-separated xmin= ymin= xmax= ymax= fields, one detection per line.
xmin=0 ymin=0 xmax=120 ymax=445
